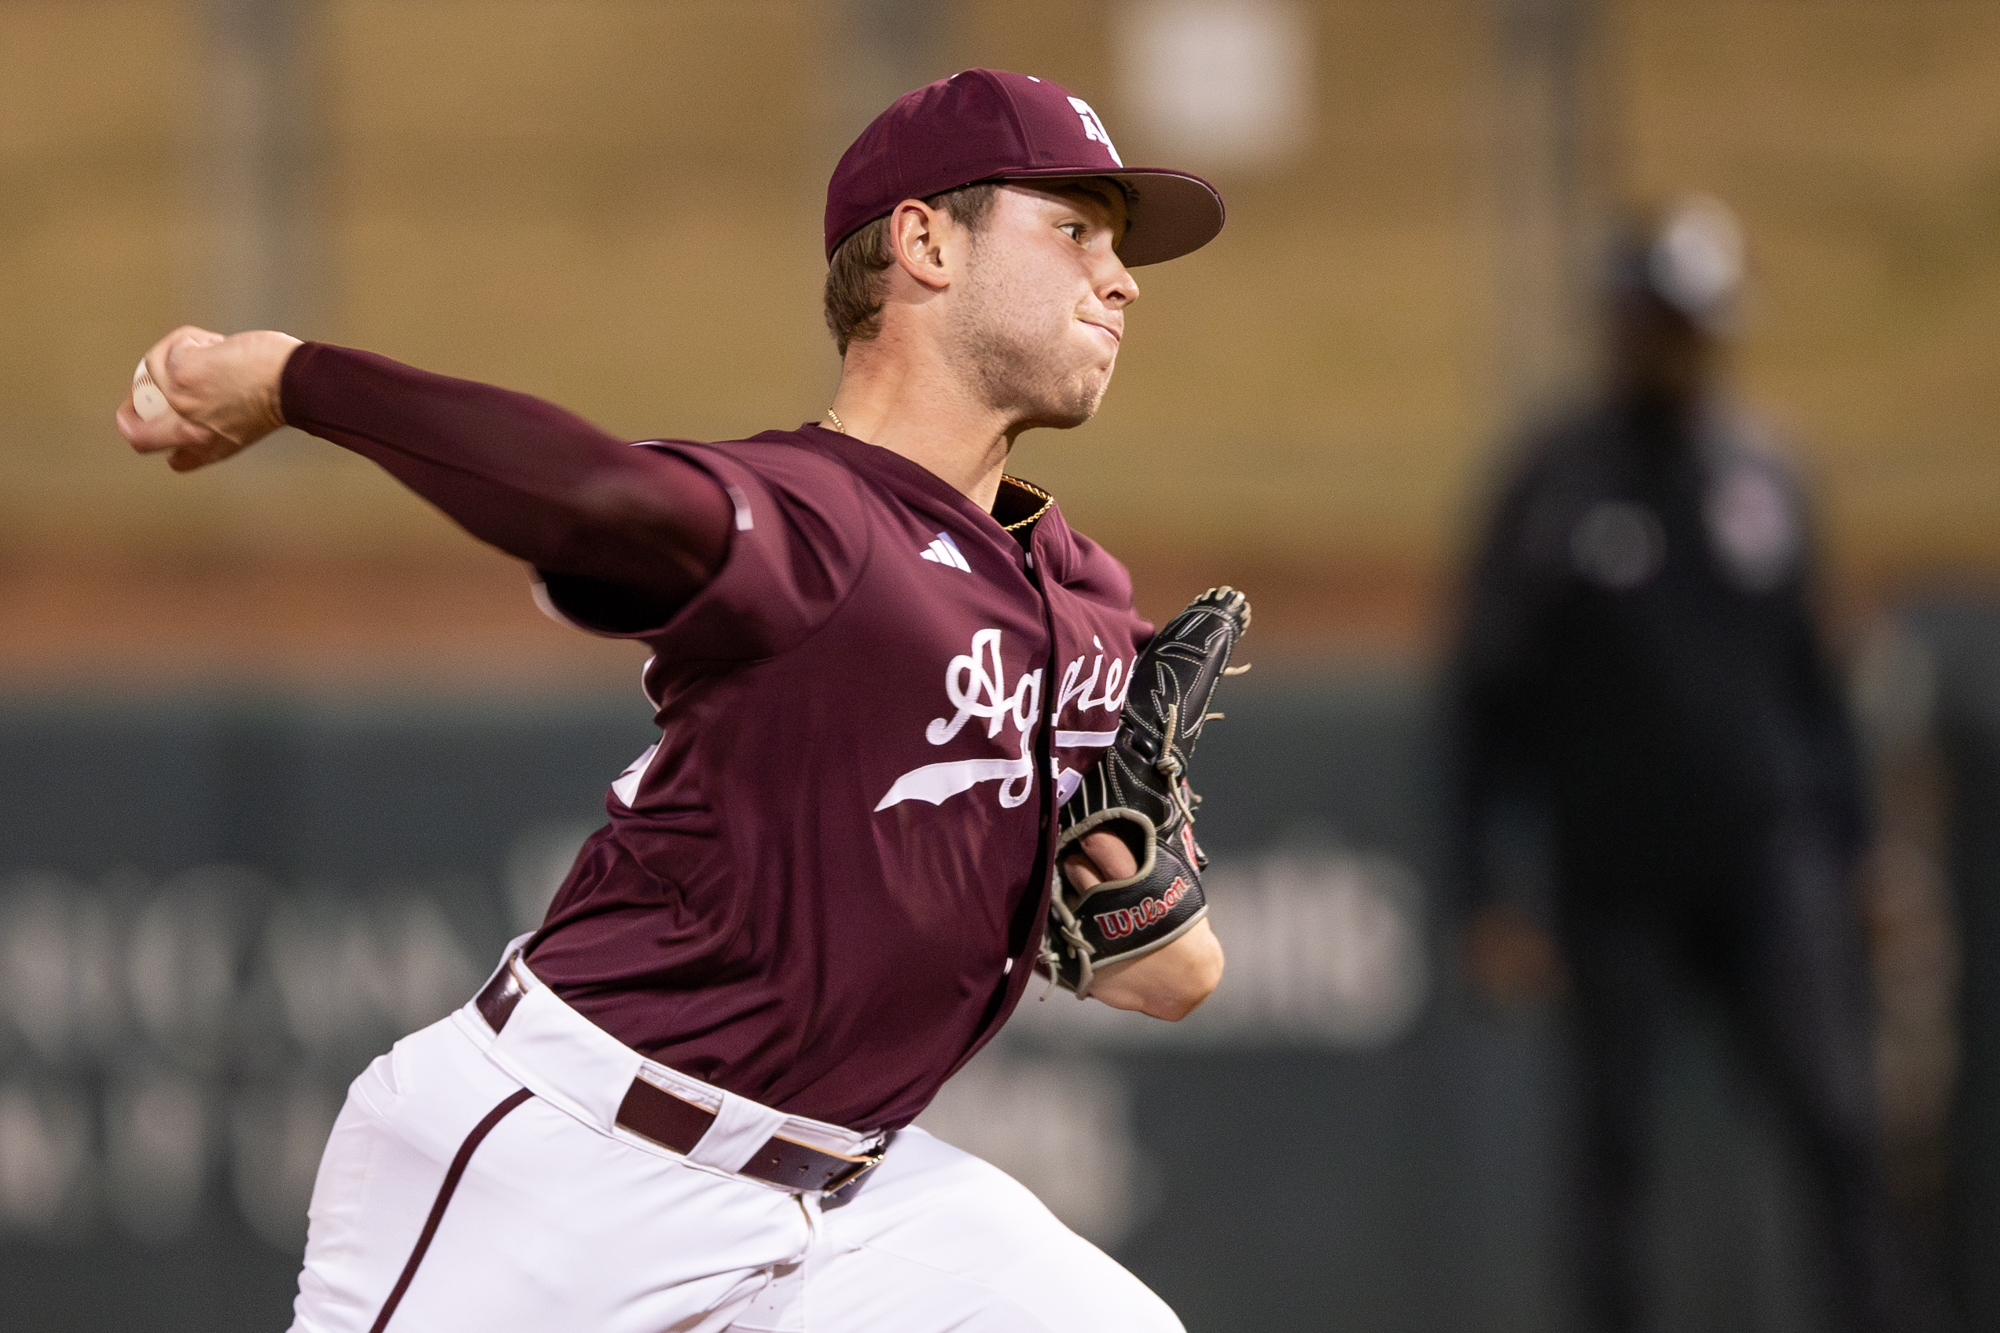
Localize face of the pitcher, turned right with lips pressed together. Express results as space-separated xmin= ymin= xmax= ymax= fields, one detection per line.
xmin=950 ymin=182 xmax=1138 ymax=428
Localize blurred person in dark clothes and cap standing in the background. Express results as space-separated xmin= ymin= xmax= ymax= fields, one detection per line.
xmin=1452 ymin=198 xmax=1936 ymax=1333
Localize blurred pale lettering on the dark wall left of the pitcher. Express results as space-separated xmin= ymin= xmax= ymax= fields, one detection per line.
xmin=0 ymin=867 xmax=484 ymax=1251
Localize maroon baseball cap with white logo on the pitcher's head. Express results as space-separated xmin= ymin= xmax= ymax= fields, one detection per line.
xmin=826 ymin=70 xmax=1224 ymax=266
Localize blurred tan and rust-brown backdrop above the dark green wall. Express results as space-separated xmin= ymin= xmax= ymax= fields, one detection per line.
xmin=0 ymin=0 xmax=2000 ymax=693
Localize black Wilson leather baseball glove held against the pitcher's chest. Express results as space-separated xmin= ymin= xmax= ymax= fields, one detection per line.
xmin=1042 ymin=586 xmax=1250 ymax=999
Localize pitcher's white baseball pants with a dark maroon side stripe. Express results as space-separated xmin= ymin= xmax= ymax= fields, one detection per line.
xmin=292 ymin=944 xmax=1180 ymax=1333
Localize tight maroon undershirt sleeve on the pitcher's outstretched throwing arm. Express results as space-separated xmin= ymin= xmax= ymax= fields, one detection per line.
xmin=280 ymin=342 xmax=734 ymax=622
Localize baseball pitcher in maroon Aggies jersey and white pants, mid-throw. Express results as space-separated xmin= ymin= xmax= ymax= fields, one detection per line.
xmin=118 ymin=70 xmax=1250 ymax=1333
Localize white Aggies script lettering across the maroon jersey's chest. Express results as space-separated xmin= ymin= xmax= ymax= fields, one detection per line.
xmin=876 ymin=628 xmax=1132 ymax=811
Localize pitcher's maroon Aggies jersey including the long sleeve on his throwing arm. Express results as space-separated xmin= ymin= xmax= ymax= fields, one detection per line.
xmin=284 ymin=344 xmax=1152 ymax=1129
